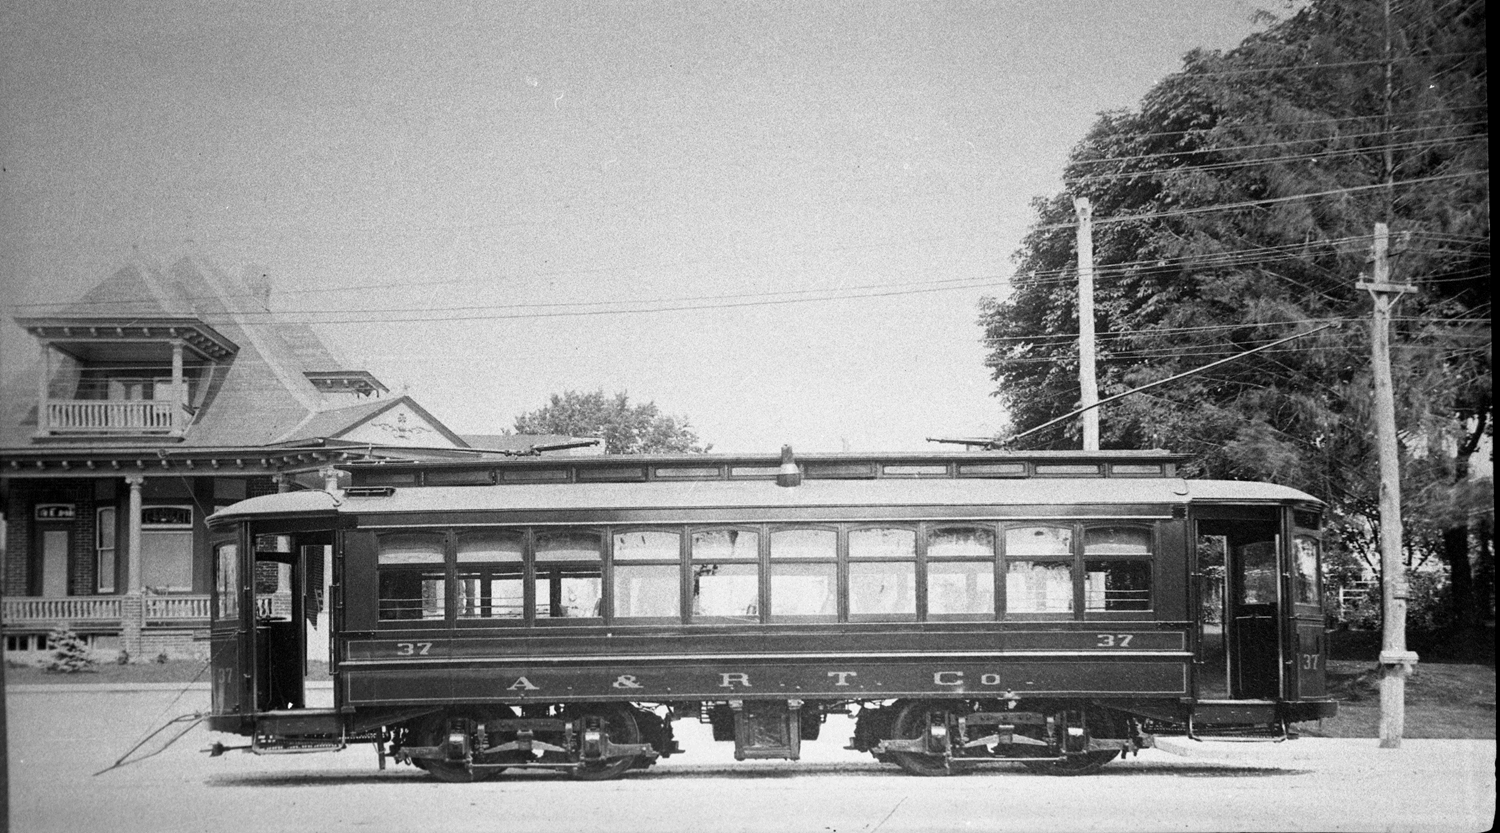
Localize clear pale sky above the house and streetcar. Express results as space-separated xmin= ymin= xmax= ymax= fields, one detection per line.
xmin=0 ymin=0 xmax=1259 ymax=452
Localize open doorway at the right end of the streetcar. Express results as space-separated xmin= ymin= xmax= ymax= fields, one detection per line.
xmin=1196 ymin=510 xmax=1281 ymax=699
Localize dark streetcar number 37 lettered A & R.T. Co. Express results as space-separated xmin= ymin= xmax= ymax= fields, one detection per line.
xmin=209 ymin=452 xmax=1335 ymax=780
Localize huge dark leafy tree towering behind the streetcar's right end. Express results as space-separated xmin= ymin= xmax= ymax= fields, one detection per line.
xmin=981 ymin=0 xmax=1493 ymax=618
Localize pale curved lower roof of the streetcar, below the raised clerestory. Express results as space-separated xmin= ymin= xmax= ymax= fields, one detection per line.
xmin=210 ymin=477 xmax=1320 ymax=522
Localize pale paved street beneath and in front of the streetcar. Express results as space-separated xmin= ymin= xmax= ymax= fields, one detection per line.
xmin=8 ymin=689 xmax=1496 ymax=833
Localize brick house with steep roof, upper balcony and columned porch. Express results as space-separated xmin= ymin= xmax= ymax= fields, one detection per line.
xmin=0 ymin=258 xmax=473 ymax=657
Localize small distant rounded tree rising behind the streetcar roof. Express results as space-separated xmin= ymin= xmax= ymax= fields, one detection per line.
xmin=516 ymin=390 xmax=713 ymax=455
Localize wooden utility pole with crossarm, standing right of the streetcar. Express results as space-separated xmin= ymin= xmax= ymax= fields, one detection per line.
xmin=1359 ymin=222 xmax=1416 ymax=749
